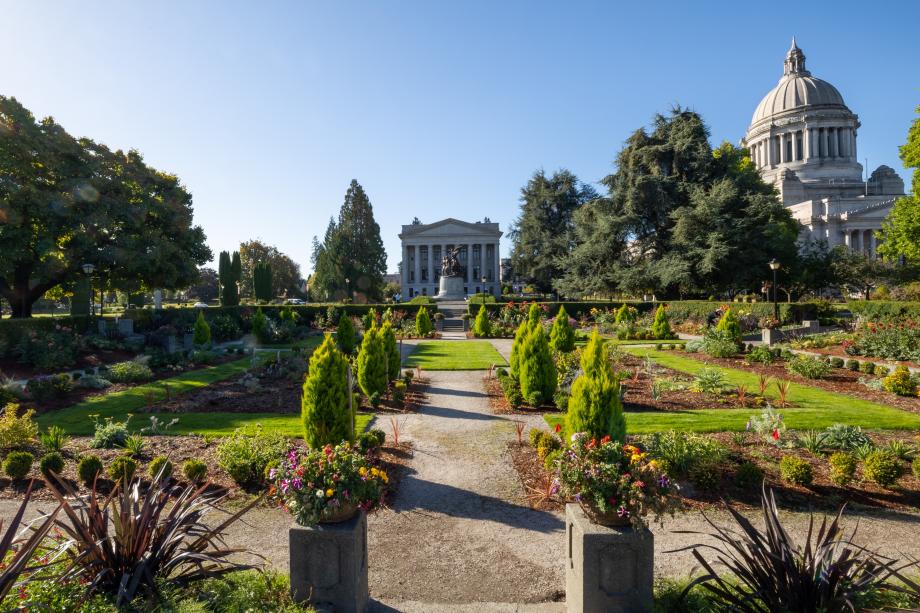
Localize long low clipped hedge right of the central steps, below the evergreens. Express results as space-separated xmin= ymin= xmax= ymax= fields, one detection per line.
xmin=467 ymin=300 xmax=820 ymax=324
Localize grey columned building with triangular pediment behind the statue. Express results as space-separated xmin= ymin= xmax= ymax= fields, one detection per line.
xmin=399 ymin=218 xmax=502 ymax=300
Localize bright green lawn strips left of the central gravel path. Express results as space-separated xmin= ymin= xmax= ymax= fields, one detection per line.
xmin=36 ymin=358 xmax=373 ymax=436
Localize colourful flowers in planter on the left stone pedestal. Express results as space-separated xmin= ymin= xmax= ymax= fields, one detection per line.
xmin=268 ymin=443 xmax=389 ymax=526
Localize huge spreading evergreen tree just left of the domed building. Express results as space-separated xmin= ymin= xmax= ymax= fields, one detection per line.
xmin=556 ymin=108 xmax=798 ymax=296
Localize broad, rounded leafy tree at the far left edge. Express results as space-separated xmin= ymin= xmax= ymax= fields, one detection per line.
xmin=0 ymin=96 xmax=211 ymax=317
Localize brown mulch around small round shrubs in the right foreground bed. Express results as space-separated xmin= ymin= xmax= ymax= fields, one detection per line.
xmin=508 ymin=432 xmax=920 ymax=513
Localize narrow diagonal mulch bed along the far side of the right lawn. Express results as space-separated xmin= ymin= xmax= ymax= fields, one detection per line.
xmin=674 ymin=352 xmax=920 ymax=413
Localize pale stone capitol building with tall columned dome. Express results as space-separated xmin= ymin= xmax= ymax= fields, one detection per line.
xmin=741 ymin=39 xmax=904 ymax=256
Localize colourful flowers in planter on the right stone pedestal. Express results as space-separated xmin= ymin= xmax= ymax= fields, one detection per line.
xmin=559 ymin=433 xmax=679 ymax=530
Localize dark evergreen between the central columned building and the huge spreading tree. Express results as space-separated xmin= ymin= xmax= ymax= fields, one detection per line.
xmin=509 ymin=169 xmax=597 ymax=292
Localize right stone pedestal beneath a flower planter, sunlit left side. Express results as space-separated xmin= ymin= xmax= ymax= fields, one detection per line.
xmin=565 ymin=504 xmax=655 ymax=613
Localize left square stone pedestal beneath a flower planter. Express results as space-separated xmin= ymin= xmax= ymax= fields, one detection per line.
xmin=289 ymin=512 xmax=369 ymax=613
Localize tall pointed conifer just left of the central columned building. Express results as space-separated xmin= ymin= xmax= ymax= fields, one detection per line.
xmin=313 ymin=180 xmax=387 ymax=302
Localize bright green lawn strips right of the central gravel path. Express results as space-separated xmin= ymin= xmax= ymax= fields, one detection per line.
xmin=546 ymin=348 xmax=920 ymax=434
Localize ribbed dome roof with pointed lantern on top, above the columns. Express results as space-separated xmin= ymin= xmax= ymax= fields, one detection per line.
xmin=751 ymin=39 xmax=846 ymax=125
